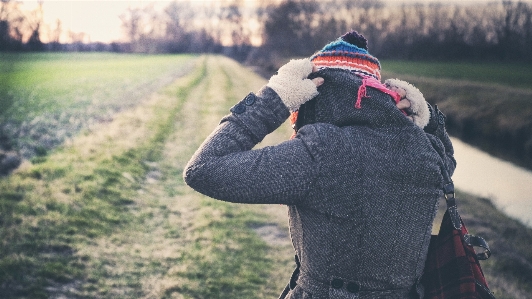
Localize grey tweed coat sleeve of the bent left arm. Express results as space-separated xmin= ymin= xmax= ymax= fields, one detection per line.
xmin=183 ymin=87 xmax=317 ymax=205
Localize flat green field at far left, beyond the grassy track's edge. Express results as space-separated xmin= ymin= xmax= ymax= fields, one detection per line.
xmin=0 ymin=53 xmax=195 ymax=162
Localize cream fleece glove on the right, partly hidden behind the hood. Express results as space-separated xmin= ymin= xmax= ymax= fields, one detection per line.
xmin=384 ymin=79 xmax=430 ymax=129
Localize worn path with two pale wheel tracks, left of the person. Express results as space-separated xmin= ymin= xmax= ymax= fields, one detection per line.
xmin=49 ymin=57 xmax=293 ymax=298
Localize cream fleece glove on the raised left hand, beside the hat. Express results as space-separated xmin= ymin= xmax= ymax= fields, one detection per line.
xmin=266 ymin=59 xmax=318 ymax=111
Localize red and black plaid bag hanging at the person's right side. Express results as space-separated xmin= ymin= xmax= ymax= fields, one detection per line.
xmin=421 ymin=212 xmax=495 ymax=299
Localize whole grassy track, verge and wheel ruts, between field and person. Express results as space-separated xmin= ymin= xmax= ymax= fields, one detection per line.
xmin=0 ymin=57 xmax=292 ymax=298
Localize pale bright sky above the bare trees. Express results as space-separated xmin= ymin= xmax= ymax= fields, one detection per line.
xmin=21 ymin=0 xmax=528 ymax=43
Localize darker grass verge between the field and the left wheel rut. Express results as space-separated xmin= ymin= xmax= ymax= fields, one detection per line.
xmin=0 ymin=55 xmax=204 ymax=298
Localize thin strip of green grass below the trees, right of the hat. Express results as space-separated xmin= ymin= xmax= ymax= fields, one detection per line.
xmin=381 ymin=60 xmax=532 ymax=89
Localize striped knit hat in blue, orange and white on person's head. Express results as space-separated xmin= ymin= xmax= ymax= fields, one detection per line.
xmin=310 ymin=31 xmax=381 ymax=81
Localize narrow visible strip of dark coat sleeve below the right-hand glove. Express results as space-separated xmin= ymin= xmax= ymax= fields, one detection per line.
xmin=424 ymin=105 xmax=456 ymax=176
